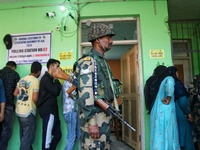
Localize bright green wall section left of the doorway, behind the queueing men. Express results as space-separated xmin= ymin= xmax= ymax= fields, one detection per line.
xmin=0 ymin=0 xmax=78 ymax=150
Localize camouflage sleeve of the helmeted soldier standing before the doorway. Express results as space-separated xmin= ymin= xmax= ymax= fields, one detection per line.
xmin=78 ymin=57 xmax=96 ymax=125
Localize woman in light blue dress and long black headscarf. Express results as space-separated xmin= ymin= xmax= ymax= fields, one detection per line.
xmin=144 ymin=66 xmax=180 ymax=150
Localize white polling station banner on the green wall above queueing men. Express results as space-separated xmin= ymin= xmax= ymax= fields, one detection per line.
xmin=8 ymin=32 xmax=52 ymax=64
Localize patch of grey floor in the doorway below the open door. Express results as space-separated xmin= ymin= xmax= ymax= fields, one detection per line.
xmin=110 ymin=133 xmax=134 ymax=150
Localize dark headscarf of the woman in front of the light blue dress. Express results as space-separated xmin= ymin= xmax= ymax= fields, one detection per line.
xmin=167 ymin=66 xmax=189 ymax=99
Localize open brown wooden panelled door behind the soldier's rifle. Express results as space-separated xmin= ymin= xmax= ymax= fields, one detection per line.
xmin=121 ymin=45 xmax=141 ymax=150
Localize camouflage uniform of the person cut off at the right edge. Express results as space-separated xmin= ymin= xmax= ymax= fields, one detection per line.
xmin=189 ymin=75 xmax=200 ymax=143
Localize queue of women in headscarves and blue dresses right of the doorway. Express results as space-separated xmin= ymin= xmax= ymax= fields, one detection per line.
xmin=144 ymin=65 xmax=200 ymax=150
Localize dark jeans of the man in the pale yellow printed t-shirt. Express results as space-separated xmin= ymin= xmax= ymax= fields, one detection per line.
xmin=18 ymin=114 xmax=36 ymax=150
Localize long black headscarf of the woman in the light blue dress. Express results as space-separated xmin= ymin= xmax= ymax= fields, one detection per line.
xmin=144 ymin=65 xmax=169 ymax=114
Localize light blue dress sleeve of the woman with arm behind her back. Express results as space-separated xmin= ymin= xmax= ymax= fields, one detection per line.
xmin=165 ymin=77 xmax=175 ymax=97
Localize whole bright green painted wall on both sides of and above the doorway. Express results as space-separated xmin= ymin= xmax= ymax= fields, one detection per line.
xmin=0 ymin=0 xmax=172 ymax=150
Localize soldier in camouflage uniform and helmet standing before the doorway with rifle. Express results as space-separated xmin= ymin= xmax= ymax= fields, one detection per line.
xmin=76 ymin=24 xmax=118 ymax=150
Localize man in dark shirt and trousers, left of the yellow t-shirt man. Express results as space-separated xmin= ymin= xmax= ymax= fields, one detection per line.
xmin=0 ymin=61 xmax=20 ymax=150
